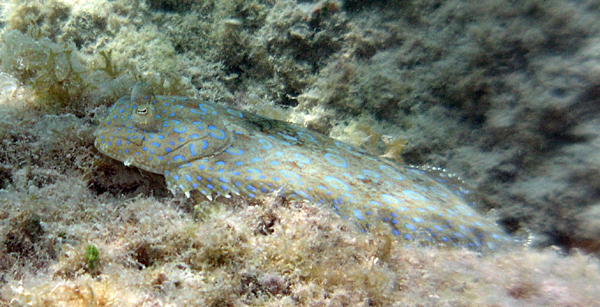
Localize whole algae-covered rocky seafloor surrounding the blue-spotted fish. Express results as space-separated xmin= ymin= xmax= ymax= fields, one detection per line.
xmin=0 ymin=0 xmax=600 ymax=307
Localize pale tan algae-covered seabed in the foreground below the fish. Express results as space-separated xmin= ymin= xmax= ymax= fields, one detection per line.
xmin=0 ymin=192 xmax=600 ymax=306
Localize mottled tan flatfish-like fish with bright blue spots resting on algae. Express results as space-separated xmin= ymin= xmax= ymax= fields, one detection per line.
xmin=95 ymin=84 xmax=511 ymax=251
